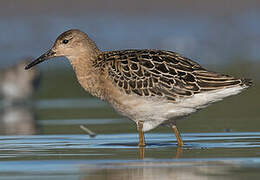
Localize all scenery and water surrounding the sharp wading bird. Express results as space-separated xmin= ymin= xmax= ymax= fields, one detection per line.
xmin=0 ymin=0 xmax=260 ymax=180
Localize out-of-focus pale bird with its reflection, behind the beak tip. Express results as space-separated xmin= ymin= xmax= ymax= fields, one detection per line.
xmin=0 ymin=60 xmax=40 ymax=135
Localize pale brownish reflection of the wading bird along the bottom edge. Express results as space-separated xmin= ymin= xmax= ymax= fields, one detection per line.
xmin=80 ymin=160 xmax=236 ymax=180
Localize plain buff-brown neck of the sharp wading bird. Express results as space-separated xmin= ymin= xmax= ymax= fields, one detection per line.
xmin=69 ymin=54 xmax=104 ymax=99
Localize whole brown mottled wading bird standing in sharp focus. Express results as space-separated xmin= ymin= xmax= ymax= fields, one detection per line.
xmin=25 ymin=29 xmax=251 ymax=146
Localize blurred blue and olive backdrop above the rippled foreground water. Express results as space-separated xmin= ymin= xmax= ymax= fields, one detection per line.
xmin=0 ymin=0 xmax=260 ymax=134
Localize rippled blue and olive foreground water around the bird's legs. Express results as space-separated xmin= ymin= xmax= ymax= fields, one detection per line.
xmin=0 ymin=133 xmax=260 ymax=179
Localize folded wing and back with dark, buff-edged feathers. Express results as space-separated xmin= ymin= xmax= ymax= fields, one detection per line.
xmin=95 ymin=49 xmax=250 ymax=101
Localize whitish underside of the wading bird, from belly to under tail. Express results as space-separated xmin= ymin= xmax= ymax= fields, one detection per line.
xmin=108 ymin=87 xmax=243 ymax=131
